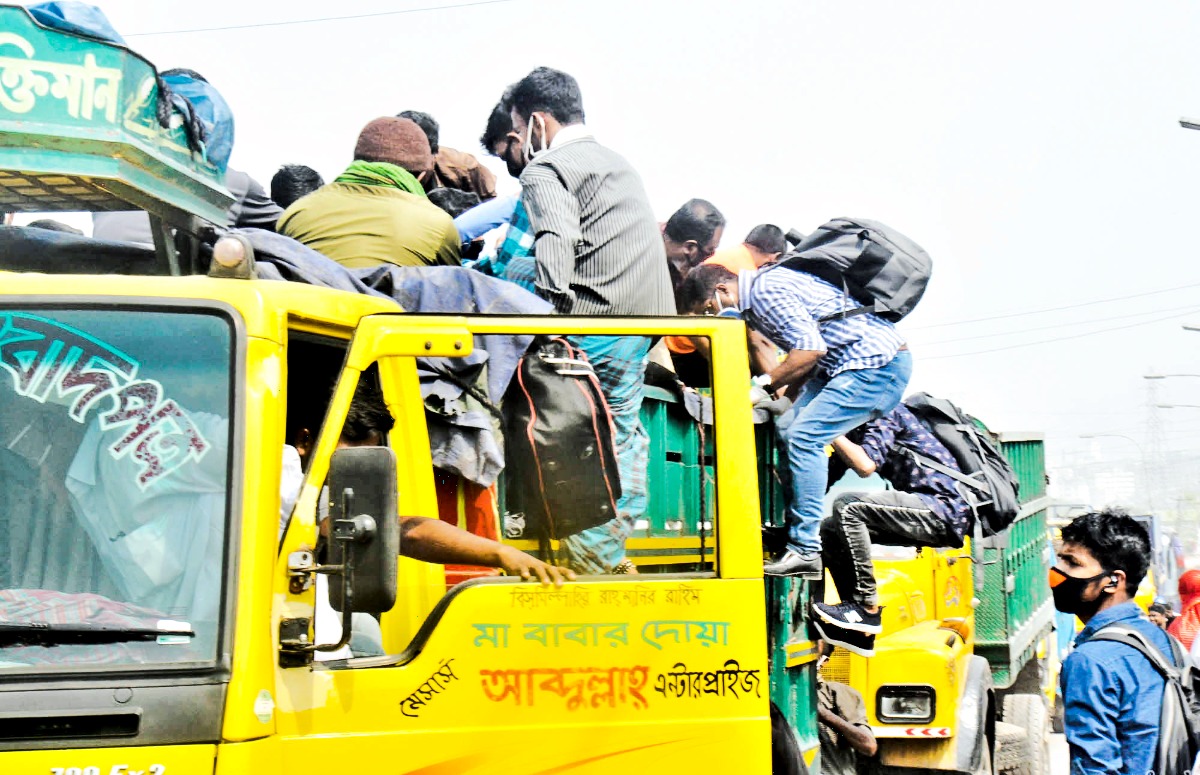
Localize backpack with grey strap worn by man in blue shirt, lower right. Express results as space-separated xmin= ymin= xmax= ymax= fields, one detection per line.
xmin=1091 ymin=624 xmax=1200 ymax=775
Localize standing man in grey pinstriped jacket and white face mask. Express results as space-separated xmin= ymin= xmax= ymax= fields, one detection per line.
xmin=511 ymin=67 xmax=674 ymax=573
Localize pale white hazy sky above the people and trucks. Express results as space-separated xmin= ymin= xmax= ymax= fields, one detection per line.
xmin=75 ymin=0 xmax=1200 ymax=482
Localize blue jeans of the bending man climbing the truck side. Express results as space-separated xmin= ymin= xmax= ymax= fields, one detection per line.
xmin=775 ymin=350 xmax=912 ymax=554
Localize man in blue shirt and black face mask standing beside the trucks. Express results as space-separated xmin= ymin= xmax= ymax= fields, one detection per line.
xmin=1050 ymin=511 xmax=1174 ymax=775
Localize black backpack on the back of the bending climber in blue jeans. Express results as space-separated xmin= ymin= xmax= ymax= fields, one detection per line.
xmin=779 ymin=218 xmax=934 ymax=323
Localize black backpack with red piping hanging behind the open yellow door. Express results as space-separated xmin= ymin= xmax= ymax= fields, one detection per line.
xmin=502 ymin=337 xmax=620 ymax=553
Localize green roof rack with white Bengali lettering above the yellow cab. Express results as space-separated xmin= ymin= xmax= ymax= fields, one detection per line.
xmin=0 ymin=5 xmax=233 ymax=275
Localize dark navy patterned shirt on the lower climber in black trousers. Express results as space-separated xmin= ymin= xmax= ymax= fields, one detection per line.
xmin=848 ymin=404 xmax=972 ymax=546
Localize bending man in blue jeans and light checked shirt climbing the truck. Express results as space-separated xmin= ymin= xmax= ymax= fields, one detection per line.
xmin=679 ymin=264 xmax=912 ymax=578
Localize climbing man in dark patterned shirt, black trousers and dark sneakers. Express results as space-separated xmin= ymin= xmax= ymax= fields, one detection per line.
xmin=812 ymin=404 xmax=973 ymax=656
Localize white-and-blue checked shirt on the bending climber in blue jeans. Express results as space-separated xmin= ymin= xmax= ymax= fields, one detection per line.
xmin=738 ymin=266 xmax=904 ymax=378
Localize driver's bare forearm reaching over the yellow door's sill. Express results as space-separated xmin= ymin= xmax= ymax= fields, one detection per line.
xmin=400 ymin=517 xmax=575 ymax=587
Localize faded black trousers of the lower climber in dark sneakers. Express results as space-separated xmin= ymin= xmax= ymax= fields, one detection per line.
xmin=821 ymin=489 xmax=962 ymax=606
